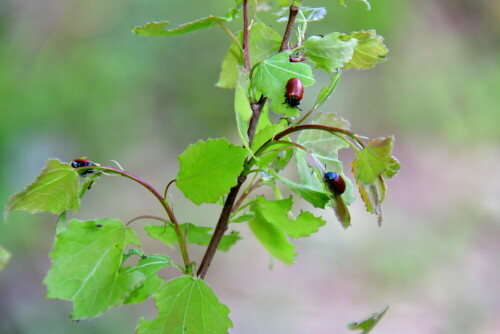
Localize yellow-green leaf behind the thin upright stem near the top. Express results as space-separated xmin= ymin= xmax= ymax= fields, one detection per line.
xmin=216 ymin=22 xmax=282 ymax=88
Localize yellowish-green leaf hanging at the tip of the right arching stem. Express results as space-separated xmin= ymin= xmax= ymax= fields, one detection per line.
xmin=352 ymin=137 xmax=394 ymax=184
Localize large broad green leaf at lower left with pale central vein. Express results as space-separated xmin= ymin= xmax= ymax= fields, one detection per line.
xmin=44 ymin=218 xmax=145 ymax=319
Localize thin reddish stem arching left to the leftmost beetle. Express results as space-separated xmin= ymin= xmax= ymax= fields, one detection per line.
xmin=81 ymin=166 xmax=191 ymax=270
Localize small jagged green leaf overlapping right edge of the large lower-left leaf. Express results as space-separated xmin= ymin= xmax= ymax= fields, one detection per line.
xmin=120 ymin=254 xmax=172 ymax=304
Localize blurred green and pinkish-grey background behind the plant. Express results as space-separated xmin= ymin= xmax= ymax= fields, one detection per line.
xmin=0 ymin=0 xmax=500 ymax=334
